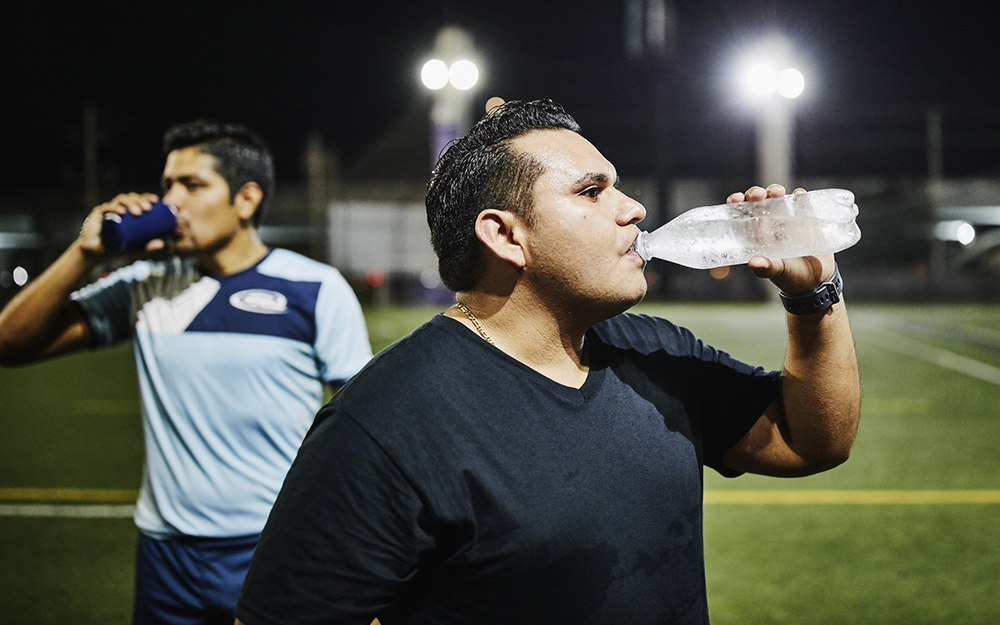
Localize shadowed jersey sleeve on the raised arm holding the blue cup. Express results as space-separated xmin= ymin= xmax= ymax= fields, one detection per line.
xmin=70 ymin=263 xmax=145 ymax=347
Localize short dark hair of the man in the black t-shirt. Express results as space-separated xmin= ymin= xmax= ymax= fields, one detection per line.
xmin=424 ymin=99 xmax=580 ymax=291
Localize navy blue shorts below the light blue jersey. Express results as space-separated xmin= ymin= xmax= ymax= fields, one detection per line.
xmin=132 ymin=533 xmax=260 ymax=625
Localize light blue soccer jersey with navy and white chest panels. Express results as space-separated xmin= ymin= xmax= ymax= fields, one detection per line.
xmin=73 ymin=249 xmax=371 ymax=538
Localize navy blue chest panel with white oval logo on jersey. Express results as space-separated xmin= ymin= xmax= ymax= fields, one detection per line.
xmin=186 ymin=267 xmax=320 ymax=344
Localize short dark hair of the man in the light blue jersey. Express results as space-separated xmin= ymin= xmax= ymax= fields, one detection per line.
xmin=163 ymin=119 xmax=274 ymax=227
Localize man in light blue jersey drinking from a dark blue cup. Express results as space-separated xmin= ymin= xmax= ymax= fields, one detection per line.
xmin=0 ymin=121 xmax=371 ymax=624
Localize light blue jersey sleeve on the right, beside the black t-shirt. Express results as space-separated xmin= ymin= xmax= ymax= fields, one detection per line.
xmin=316 ymin=270 xmax=372 ymax=386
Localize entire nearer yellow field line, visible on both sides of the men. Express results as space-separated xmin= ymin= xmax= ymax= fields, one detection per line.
xmin=0 ymin=488 xmax=1000 ymax=505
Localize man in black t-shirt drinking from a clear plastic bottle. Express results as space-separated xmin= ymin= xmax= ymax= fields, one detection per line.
xmin=236 ymin=101 xmax=859 ymax=625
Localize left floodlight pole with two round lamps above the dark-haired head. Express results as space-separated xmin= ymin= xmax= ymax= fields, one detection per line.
xmin=420 ymin=26 xmax=479 ymax=165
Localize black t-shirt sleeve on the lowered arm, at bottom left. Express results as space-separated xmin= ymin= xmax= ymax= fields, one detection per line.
xmin=236 ymin=406 xmax=432 ymax=625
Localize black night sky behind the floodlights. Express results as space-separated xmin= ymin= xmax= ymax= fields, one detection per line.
xmin=0 ymin=0 xmax=1000 ymax=192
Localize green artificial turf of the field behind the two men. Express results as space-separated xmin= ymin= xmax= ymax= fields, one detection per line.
xmin=0 ymin=304 xmax=1000 ymax=625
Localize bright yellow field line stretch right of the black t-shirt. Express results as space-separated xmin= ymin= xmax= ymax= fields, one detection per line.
xmin=705 ymin=490 xmax=1000 ymax=505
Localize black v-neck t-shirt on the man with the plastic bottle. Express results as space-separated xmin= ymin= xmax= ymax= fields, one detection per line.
xmin=236 ymin=314 xmax=779 ymax=625
